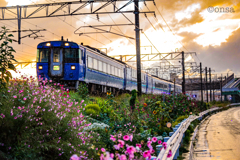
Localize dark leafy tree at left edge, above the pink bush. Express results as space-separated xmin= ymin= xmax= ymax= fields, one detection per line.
xmin=0 ymin=26 xmax=17 ymax=89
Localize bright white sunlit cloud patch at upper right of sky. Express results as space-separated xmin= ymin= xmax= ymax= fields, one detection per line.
xmin=179 ymin=7 xmax=240 ymax=47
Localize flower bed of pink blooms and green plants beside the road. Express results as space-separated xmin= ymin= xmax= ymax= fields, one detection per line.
xmin=0 ymin=73 xmax=210 ymax=160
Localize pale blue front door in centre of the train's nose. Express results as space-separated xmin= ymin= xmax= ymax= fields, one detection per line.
xmin=49 ymin=48 xmax=63 ymax=77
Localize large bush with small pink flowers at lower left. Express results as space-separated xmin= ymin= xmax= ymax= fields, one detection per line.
xmin=0 ymin=77 xmax=98 ymax=159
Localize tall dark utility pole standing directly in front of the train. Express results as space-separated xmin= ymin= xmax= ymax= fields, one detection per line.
xmin=134 ymin=0 xmax=142 ymax=95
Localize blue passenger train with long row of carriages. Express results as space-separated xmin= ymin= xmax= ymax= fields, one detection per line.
xmin=36 ymin=38 xmax=182 ymax=94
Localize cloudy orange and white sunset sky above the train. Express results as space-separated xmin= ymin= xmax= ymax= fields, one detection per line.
xmin=0 ymin=0 xmax=240 ymax=78
